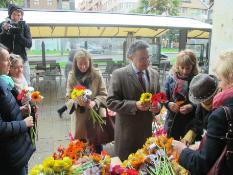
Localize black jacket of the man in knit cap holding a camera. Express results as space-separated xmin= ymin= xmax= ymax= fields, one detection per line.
xmin=0 ymin=20 xmax=32 ymax=61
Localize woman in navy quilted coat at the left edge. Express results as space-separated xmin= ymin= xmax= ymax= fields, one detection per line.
xmin=0 ymin=47 xmax=35 ymax=175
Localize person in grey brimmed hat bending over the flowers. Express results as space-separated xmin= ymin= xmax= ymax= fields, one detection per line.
xmin=182 ymin=74 xmax=218 ymax=145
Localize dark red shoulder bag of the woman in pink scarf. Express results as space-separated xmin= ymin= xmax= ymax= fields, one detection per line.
xmin=207 ymin=107 xmax=233 ymax=175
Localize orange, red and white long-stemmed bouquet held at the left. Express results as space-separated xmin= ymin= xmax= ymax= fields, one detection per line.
xmin=17 ymin=86 xmax=44 ymax=145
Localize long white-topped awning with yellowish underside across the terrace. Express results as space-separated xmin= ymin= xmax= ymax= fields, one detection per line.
xmin=0 ymin=10 xmax=212 ymax=38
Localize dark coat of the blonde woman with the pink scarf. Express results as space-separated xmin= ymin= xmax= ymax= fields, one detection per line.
xmin=179 ymin=98 xmax=233 ymax=175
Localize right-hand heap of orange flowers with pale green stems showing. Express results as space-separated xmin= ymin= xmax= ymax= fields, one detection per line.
xmin=112 ymin=133 xmax=188 ymax=175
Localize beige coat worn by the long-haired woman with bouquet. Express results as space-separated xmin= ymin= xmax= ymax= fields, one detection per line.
xmin=66 ymin=68 xmax=107 ymax=139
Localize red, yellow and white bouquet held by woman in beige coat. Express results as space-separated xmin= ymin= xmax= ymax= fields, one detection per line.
xmin=71 ymin=85 xmax=106 ymax=128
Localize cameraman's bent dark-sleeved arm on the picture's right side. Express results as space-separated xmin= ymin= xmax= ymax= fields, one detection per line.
xmin=16 ymin=24 xmax=32 ymax=48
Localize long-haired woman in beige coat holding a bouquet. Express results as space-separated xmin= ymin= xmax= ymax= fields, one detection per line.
xmin=66 ymin=49 xmax=107 ymax=152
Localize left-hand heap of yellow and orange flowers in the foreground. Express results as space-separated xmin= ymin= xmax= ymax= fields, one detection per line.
xmin=29 ymin=140 xmax=111 ymax=175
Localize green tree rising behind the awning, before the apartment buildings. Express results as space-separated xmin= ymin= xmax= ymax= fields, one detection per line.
xmin=133 ymin=0 xmax=180 ymax=16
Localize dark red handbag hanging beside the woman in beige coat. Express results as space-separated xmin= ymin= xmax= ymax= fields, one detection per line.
xmin=87 ymin=107 xmax=115 ymax=145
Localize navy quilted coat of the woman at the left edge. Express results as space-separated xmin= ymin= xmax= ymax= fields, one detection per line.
xmin=0 ymin=80 xmax=35 ymax=169
